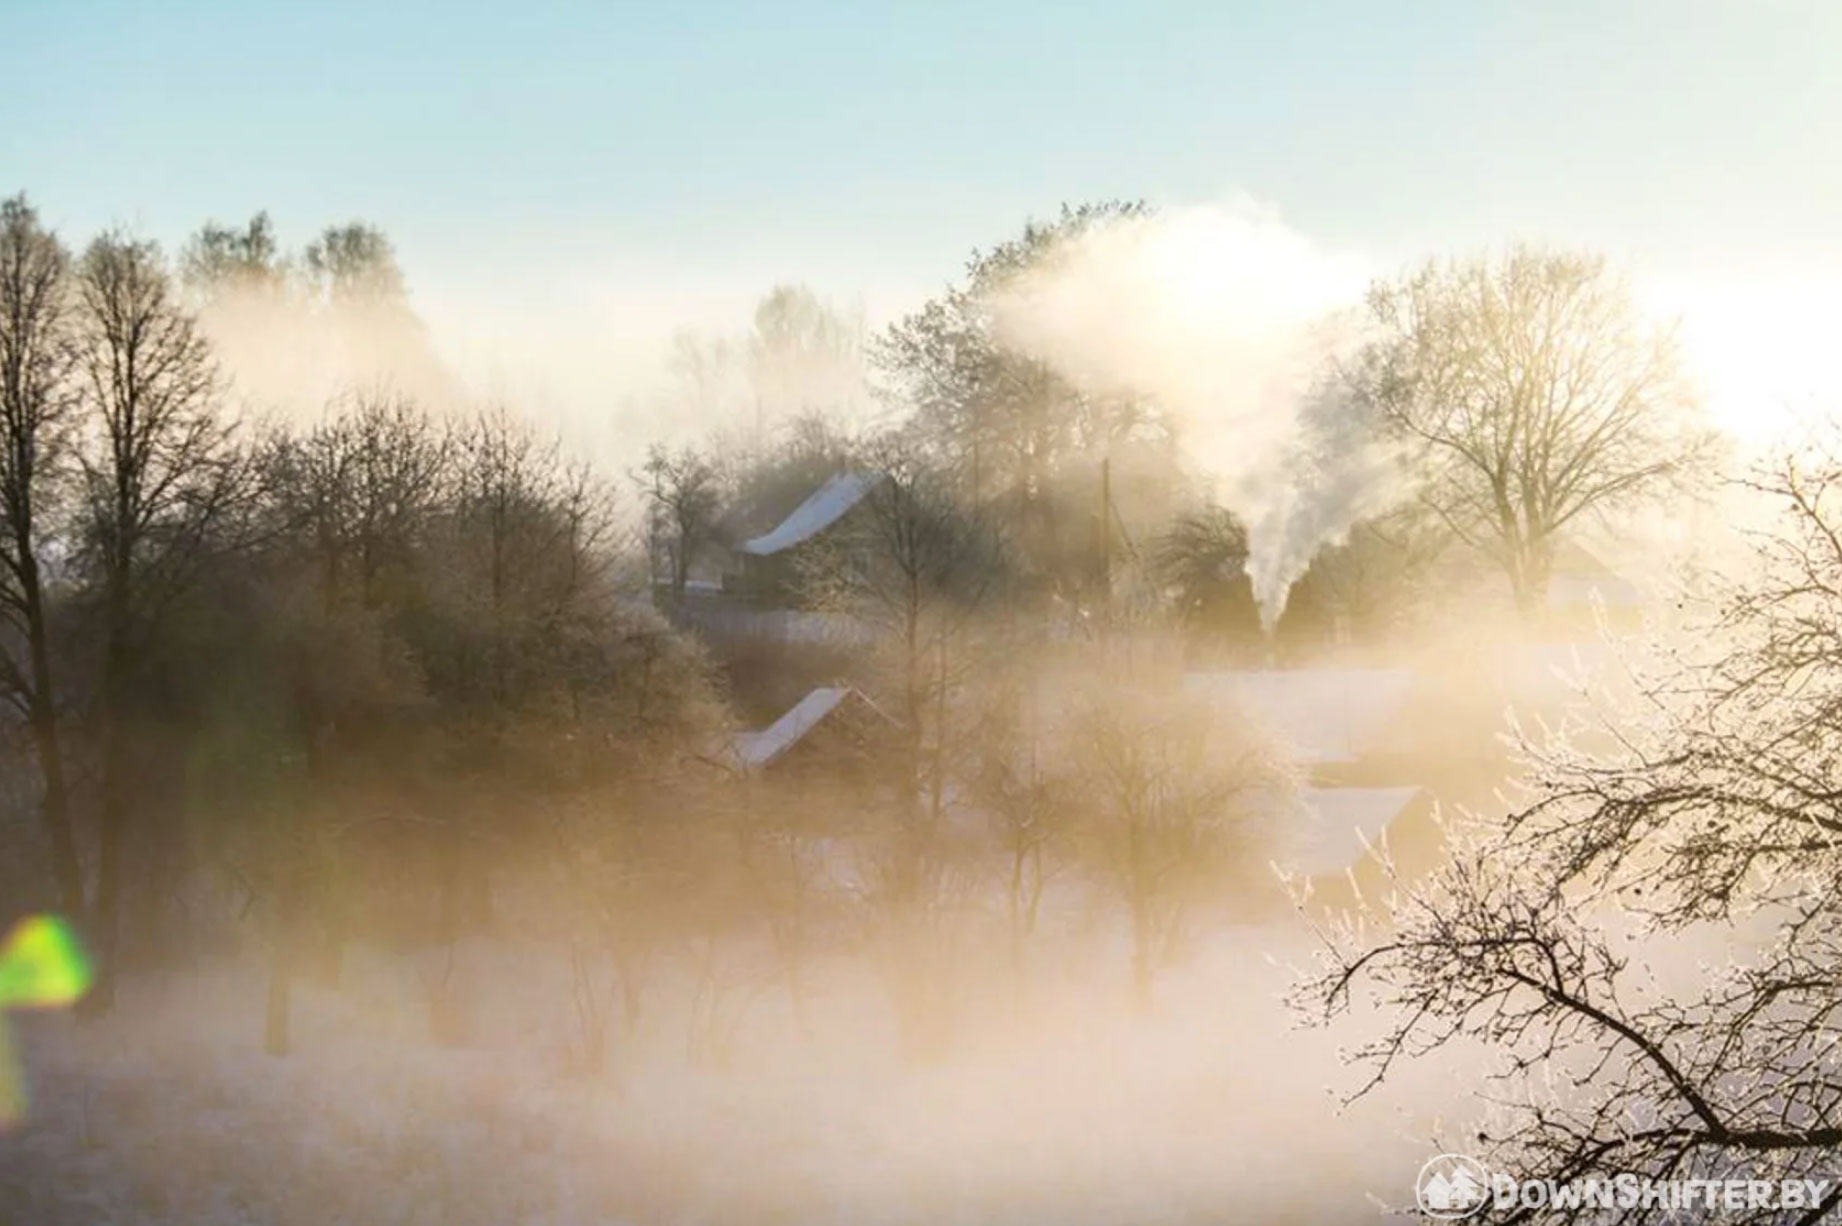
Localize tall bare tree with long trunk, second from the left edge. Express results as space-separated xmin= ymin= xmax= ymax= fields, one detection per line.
xmin=76 ymin=234 xmax=245 ymax=1011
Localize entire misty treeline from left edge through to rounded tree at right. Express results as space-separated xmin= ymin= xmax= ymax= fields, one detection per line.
xmin=0 ymin=188 xmax=1700 ymax=1064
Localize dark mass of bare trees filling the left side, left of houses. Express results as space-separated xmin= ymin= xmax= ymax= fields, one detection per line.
xmin=0 ymin=199 xmax=720 ymax=1009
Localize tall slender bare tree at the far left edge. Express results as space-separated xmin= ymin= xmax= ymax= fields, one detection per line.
xmin=0 ymin=197 xmax=83 ymax=917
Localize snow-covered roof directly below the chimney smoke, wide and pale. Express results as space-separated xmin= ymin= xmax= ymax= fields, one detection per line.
xmin=1184 ymin=668 xmax=1413 ymax=766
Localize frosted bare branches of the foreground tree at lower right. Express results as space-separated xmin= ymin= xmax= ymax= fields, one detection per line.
xmin=1302 ymin=443 xmax=1842 ymax=1222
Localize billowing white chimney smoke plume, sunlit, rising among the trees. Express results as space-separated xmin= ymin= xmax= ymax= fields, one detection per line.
xmin=993 ymin=204 xmax=1398 ymax=630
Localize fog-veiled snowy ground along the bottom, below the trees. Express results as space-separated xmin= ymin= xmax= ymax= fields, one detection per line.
xmin=0 ymin=916 xmax=1468 ymax=1226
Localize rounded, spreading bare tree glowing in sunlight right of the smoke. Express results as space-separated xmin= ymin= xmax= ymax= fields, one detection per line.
xmin=1356 ymin=247 xmax=1711 ymax=611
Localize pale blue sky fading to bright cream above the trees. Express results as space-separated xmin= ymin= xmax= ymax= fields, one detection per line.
xmin=0 ymin=0 xmax=1842 ymax=449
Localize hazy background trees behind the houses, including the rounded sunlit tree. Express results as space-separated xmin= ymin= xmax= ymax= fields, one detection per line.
xmin=647 ymin=202 xmax=1715 ymax=661
